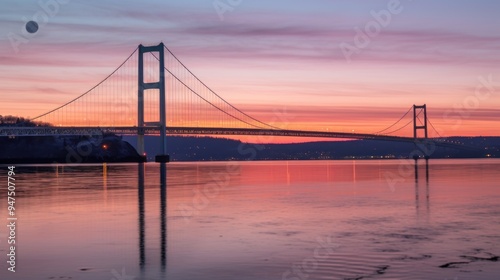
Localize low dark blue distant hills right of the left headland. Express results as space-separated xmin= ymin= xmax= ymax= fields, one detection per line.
xmin=123 ymin=136 xmax=500 ymax=161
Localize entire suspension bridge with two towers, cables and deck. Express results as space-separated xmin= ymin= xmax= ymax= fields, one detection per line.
xmin=0 ymin=43 xmax=459 ymax=160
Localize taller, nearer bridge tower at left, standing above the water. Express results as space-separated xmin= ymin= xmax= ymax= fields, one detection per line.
xmin=137 ymin=43 xmax=169 ymax=162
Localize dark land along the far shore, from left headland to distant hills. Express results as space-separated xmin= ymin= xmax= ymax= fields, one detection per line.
xmin=0 ymin=116 xmax=500 ymax=164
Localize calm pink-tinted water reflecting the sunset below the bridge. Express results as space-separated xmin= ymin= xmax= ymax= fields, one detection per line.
xmin=0 ymin=160 xmax=500 ymax=280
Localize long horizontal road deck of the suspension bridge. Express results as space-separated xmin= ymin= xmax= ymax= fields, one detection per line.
xmin=0 ymin=126 xmax=466 ymax=149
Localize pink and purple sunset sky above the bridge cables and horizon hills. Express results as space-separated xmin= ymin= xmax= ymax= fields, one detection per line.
xmin=0 ymin=0 xmax=500 ymax=140
